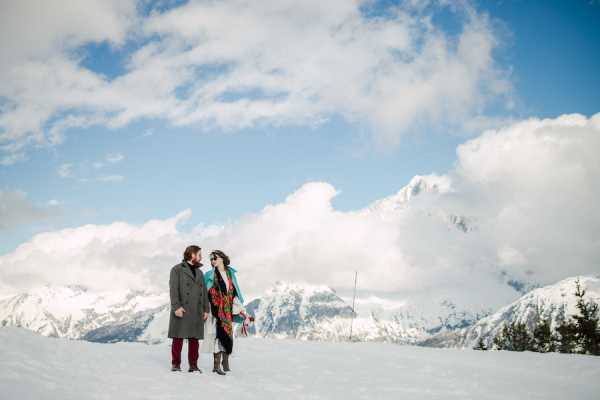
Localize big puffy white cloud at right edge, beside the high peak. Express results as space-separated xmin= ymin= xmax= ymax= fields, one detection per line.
xmin=450 ymin=114 xmax=600 ymax=282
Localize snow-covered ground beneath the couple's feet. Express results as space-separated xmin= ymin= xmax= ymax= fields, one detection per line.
xmin=0 ymin=328 xmax=600 ymax=400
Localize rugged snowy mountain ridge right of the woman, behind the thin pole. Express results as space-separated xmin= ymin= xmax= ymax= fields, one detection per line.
xmin=241 ymin=282 xmax=480 ymax=343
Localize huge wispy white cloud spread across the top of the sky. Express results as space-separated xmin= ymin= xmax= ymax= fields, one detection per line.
xmin=0 ymin=0 xmax=510 ymax=162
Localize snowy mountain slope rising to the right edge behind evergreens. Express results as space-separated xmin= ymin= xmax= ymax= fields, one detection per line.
xmin=420 ymin=276 xmax=600 ymax=348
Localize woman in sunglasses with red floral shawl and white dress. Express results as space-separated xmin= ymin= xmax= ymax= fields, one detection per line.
xmin=204 ymin=250 xmax=245 ymax=375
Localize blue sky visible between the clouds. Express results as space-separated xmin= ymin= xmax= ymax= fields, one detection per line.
xmin=0 ymin=1 xmax=600 ymax=253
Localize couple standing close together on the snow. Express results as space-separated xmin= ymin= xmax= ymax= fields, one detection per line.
xmin=168 ymin=245 xmax=252 ymax=375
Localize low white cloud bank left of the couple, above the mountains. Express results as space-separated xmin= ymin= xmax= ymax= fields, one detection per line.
xmin=0 ymin=211 xmax=190 ymax=289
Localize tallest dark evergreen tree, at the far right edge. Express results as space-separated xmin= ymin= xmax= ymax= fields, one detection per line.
xmin=573 ymin=279 xmax=600 ymax=355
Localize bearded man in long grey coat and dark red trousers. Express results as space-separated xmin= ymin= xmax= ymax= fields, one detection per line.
xmin=168 ymin=245 xmax=209 ymax=373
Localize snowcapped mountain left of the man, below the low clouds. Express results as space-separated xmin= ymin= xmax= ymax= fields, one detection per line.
xmin=0 ymin=286 xmax=168 ymax=342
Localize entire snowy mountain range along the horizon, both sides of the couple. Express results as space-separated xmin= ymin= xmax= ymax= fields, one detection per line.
xmin=0 ymin=276 xmax=600 ymax=348
